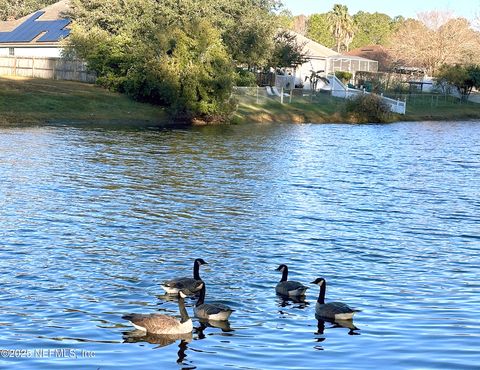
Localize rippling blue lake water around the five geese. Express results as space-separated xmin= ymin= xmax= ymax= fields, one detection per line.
xmin=0 ymin=122 xmax=480 ymax=370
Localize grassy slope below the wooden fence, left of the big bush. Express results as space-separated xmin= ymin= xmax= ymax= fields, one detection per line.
xmin=0 ymin=78 xmax=166 ymax=124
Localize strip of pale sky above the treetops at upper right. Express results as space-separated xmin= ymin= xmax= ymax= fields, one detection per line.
xmin=282 ymin=0 xmax=480 ymax=20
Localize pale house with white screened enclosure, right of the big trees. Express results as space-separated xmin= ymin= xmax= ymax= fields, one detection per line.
xmin=282 ymin=31 xmax=378 ymax=88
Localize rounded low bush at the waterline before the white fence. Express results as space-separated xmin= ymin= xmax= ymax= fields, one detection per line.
xmin=345 ymin=94 xmax=392 ymax=123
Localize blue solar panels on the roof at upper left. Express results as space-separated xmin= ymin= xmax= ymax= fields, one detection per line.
xmin=0 ymin=11 xmax=71 ymax=43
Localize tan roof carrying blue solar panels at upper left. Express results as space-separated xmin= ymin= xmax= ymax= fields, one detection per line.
xmin=0 ymin=0 xmax=71 ymax=46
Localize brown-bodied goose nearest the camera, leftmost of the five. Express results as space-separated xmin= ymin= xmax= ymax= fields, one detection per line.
xmin=122 ymin=290 xmax=196 ymax=334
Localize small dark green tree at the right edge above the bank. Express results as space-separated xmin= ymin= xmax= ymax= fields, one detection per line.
xmin=437 ymin=64 xmax=480 ymax=101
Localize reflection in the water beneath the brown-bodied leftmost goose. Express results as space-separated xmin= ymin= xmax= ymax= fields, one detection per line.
xmin=123 ymin=330 xmax=193 ymax=364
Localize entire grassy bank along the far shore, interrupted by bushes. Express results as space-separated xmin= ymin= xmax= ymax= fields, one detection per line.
xmin=0 ymin=77 xmax=480 ymax=125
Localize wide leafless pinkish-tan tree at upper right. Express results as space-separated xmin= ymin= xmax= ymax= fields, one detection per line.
xmin=390 ymin=11 xmax=480 ymax=75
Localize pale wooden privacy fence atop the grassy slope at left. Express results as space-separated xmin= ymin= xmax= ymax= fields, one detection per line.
xmin=0 ymin=57 xmax=96 ymax=83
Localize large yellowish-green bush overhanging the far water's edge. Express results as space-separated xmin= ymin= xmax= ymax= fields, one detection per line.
xmin=71 ymin=21 xmax=235 ymax=122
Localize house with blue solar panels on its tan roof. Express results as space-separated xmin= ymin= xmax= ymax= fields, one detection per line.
xmin=0 ymin=0 xmax=71 ymax=58
